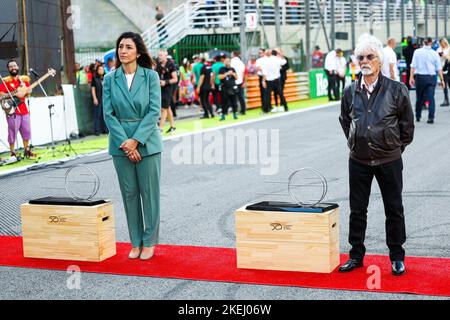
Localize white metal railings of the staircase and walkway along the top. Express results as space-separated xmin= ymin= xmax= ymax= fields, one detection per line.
xmin=143 ymin=0 xmax=450 ymax=48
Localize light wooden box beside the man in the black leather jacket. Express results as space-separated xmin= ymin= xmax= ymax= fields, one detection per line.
xmin=236 ymin=207 xmax=340 ymax=273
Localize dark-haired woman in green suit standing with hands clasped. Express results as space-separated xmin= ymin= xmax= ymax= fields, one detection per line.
xmin=103 ymin=32 xmax=162 ymax=260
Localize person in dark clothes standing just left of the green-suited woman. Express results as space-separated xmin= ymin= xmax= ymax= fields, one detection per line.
xmin=91 ymin=64 xmax=108 ymax=136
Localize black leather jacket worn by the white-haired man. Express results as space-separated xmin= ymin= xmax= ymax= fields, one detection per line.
xmin=339 ymin=75 xmax=414 ymax=166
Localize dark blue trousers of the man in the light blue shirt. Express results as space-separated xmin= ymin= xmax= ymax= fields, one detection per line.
xmin=416 ymin=74 xmax=436 ymax=120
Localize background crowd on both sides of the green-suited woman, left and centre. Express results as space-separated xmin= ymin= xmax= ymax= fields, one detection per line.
xmin=75 ymin=43 xmax=289 ymax=135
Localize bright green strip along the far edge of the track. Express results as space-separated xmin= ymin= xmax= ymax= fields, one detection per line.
xmin=0 ymin=97 xmax=328 ymax=172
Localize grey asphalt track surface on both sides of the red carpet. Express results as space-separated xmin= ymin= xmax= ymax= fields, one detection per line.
xmin=0 ymin=90 xmax=450 ymax=300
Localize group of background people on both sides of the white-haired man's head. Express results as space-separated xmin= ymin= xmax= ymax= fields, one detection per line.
xmin=324 ymin=36 xmax=450 ymax=124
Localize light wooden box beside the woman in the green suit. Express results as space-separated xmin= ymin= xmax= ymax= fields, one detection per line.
xmin=21 ymin=202 xmax=116 ymax=262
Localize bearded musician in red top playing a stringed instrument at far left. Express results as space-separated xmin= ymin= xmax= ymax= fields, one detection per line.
xmin=0 ymin=59 xmax=36 ymax=158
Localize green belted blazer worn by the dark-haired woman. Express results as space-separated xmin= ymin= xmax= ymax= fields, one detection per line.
xmin=103 ymin=66 xmax=163 ymax=157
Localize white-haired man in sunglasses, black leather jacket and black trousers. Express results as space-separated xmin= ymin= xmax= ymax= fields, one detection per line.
xmin=339 ymin=35 xmax=414 ymax=275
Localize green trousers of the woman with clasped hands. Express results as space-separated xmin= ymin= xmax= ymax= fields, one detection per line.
xmin=113 ymin=153 xmax=161 ymax=248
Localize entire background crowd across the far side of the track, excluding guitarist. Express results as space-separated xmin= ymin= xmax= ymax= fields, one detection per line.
xmin=71 ymin=31 xmax=450 ymax=139
